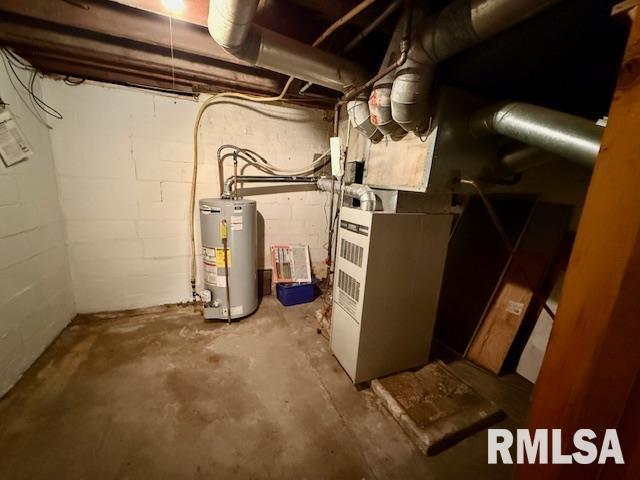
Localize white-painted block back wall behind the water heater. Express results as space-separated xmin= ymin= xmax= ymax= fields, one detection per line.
xmin=44 ymin=80 xmax=331 ymax=312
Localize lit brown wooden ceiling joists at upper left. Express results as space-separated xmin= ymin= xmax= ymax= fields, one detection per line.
xmin=0 ymin=0 xmax=334 ymax=104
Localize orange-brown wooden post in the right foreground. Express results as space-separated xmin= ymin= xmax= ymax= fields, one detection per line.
xmin=518 ymin=12 xmax=640 ymax=479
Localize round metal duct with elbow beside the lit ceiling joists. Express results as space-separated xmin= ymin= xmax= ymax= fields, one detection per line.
xmin=208 ymin=0 xmax=366 ymax=91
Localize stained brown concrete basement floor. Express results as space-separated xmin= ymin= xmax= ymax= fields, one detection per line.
xmin=0 ymin=297 xmax=529 ymax=480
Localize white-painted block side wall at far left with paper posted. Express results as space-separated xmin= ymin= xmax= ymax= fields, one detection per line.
xmin=0 ymin=68 xmax=75 ymax=396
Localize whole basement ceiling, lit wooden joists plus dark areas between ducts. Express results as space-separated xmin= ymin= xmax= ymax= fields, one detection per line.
xmin=0 ymin=0 xmax=628 ymax=118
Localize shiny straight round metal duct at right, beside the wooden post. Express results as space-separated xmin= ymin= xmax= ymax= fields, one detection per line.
xmin=469 ymin=102 xmax=604 ymax=168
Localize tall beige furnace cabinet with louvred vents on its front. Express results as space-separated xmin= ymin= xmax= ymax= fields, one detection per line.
xmin=331 ymin=207 xmax=452 ymax=383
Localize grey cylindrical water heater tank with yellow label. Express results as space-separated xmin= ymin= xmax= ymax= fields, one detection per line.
xmin=200 ymin=198 xmax=258 ymax=320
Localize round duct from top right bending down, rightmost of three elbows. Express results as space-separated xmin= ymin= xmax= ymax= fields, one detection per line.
xmin=391 ymin=0 xmax=557 ymax=132
